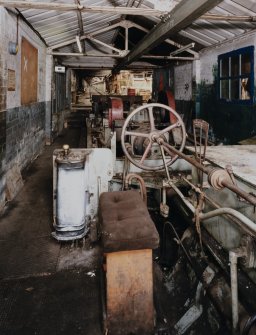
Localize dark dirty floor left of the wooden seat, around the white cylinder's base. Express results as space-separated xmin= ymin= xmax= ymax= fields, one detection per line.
xmin=0 ymin=128 xmax=102 ymax=335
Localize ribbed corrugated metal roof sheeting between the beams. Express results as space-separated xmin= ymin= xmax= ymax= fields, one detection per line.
xmin=3 ymin=0 xmax=256 ymax=67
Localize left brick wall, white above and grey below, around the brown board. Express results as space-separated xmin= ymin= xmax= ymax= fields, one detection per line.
xmin=0 ymin=7 xmax=51 ymax=209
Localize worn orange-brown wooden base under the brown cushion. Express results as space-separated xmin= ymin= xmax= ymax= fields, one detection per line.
xmin=106 ymin=249 xmax=154 ymax=335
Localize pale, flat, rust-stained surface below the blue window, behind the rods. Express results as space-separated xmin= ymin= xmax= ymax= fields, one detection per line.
xmin=187 ymin=145 xmax=256 ymax=186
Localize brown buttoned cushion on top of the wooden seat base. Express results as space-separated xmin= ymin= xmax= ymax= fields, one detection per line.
xmin=99 ymin=191 xmax=159 ymax=252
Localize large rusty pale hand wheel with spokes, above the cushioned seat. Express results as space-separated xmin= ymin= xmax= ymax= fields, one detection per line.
xmin=121 ymin=103 xmax=186 ymax=171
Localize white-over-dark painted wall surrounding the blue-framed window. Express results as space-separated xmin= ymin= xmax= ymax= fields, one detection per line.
xmin=193 ymin=33 xmax=256 ymax=144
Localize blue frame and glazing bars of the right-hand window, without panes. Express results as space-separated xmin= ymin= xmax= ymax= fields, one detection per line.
xmin=218 ymin=46 xmax=254 ymax=105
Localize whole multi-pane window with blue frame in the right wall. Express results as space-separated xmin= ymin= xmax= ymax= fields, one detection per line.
xmin=218 ymin=46 xmax=254 ymax=104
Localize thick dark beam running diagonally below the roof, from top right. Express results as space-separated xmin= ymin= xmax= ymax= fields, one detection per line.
xmin=114 ymin=0 xmax=222 ymax=72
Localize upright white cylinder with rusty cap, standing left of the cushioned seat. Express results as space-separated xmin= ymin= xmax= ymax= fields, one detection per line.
xmin=52 ymin=146 xmax=88 ymax=241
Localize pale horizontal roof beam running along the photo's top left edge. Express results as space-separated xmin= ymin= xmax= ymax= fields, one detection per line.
xmin=0 ymin=0 xmax=167 ymax=17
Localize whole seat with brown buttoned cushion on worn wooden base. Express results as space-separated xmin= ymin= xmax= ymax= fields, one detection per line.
xmin=99 ymin=191 xmax=159 ymax=335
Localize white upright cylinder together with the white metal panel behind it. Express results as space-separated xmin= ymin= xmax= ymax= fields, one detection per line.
xmin=52 ymin=145 xmax=113 ymax=241
